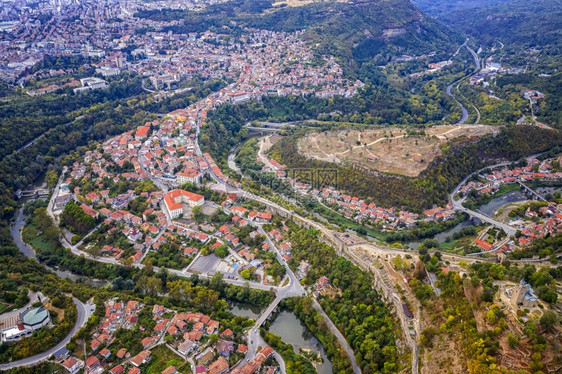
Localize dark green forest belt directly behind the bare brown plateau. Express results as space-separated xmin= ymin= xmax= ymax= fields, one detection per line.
xmin=199 ymin=86 xmax=457 ymax=171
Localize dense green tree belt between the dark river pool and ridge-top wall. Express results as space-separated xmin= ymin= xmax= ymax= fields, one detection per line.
xmin=280 ymin=221 xmax=402 ymax=372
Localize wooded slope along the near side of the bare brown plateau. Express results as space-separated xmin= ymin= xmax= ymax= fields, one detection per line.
xmin=271 ymin=126 xmax=562 ymax=211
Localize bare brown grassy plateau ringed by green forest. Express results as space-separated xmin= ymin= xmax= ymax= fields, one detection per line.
xmin=299 ymin=125 xmax=497 ymax=177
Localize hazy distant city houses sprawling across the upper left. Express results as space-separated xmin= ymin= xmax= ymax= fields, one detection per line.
xmin=0 ymin=0 xmax=362 ymax=103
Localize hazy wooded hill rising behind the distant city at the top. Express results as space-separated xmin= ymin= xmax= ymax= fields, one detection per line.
xmin=136 ymin=0 xmax=463 ymax=76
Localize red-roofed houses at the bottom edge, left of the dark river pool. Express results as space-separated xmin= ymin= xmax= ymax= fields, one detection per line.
xmin=79 ymin=299 xmax=274 ymax=374
